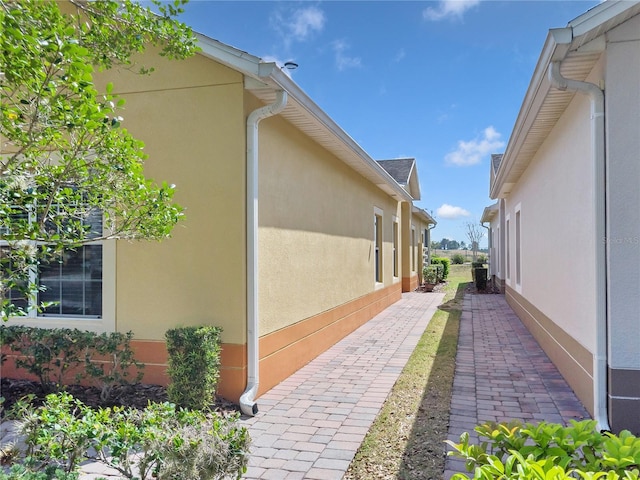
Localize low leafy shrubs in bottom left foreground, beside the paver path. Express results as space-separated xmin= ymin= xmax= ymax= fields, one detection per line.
xmin=8 ymin=393 xmax=249 ymax=480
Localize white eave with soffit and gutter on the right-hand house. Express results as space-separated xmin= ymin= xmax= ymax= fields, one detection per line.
xmin=489 ymin=0 xmax=640 ymax=199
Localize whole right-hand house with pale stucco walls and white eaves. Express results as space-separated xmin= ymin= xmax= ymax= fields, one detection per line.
xmin=482 ymin=1 xmax=640 ymax=433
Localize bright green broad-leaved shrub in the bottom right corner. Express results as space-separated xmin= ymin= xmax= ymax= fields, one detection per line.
xmin=446 ymin=420 xmax=640 ymax=480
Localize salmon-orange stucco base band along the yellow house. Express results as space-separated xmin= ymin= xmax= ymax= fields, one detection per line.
xmin=2 ymin=284 xmax=402 ymax=402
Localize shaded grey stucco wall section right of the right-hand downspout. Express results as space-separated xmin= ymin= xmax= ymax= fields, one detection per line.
xmin=605 ymin=15 xmax=640 ymax=369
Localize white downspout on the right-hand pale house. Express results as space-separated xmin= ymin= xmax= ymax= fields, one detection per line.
xmin=548 ymin=62 xmax=610 ymax=430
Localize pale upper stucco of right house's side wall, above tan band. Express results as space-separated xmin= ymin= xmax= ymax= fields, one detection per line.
xmin=504 ymin=84 xmax=595 ymax=351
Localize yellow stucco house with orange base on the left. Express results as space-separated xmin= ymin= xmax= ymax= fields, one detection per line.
xmin=5 ymin=29 xmax=435 ymax=413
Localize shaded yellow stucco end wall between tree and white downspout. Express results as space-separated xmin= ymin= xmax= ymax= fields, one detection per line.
xmin=107 ymin=56 xmax=246 ymax=343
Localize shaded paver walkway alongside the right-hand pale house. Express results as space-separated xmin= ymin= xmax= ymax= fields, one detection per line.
xmin=445 ymin=295 xmax=590 ymax=478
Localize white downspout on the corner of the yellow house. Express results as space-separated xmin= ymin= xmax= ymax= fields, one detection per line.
xmin=240 ymin=90 xmax=287 ymax=416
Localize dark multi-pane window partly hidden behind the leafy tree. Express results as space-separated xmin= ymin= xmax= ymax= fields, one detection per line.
xmin=1 ymin=203 xmax=103 ymax=318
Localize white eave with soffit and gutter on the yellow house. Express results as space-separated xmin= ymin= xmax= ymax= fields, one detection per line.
xmin=196 ymin=34 xmax=410 ymax=202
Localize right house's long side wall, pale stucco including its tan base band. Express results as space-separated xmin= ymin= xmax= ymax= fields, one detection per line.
xmin=504 ymin=89 xmax=595 ymax=405
